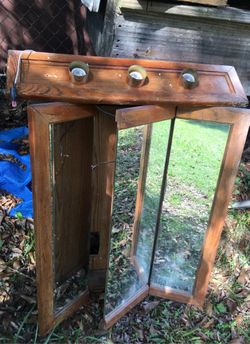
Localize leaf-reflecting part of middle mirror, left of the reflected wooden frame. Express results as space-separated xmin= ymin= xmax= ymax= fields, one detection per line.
xmin=104 ymin=126 xmax=147 ymax=316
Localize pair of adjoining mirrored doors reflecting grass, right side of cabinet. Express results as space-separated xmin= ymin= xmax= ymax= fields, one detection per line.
xmin=105 ymin=108 xmax=249 ymax=327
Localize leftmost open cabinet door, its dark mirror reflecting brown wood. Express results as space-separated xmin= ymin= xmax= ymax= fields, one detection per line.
xmin=28 ymin=103 xmax=95 ymax=334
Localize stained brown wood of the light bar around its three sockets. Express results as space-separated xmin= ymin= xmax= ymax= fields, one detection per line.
xmin=7 ymin=51 xmax=247 ymax=106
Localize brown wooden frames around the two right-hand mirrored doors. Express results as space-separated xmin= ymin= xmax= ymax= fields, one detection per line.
xmin=105 ymin=106 xmax=250 ymax=328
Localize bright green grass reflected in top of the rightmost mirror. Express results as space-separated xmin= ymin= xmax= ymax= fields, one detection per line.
xmin=169 ymin=120 xmax=229 ymax=197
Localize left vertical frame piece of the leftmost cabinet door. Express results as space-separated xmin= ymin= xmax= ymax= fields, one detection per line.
xmin=28 ymin=108 xmax=54 ymax=335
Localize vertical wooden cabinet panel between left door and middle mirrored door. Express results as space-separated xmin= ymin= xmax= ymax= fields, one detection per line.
xmin=90 ymin=107 xmax=117 ymax=280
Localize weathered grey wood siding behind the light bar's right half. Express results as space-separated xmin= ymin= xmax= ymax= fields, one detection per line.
xmin=112 ymin=9 xmax=250 ymax=95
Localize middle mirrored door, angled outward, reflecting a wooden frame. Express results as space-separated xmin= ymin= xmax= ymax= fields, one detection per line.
xmin=104 ymin=107 xmax=173 ymax=327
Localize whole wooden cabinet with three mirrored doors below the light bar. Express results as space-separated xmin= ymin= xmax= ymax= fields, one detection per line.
xmin=28 ymin=103 xmax=250 ymax=335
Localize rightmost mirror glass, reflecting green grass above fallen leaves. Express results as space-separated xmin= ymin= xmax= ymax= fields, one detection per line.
xmin=151 ymin=119 xmax=230 ymax=293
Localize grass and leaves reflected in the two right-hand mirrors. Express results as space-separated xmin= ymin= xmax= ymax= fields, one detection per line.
xmin=105 ymin=120 xmax=228 ymax=314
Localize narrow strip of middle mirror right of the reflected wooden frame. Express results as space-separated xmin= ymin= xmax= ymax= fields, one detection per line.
xmin=134 ymin=120 xmax=171 ymax=283
